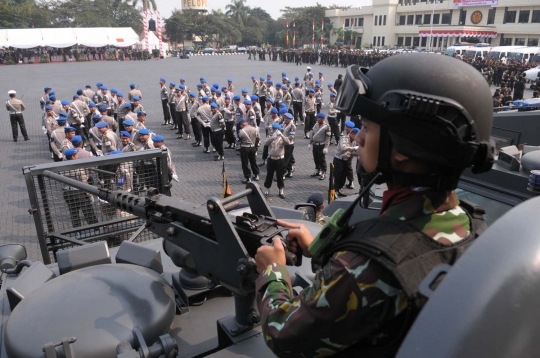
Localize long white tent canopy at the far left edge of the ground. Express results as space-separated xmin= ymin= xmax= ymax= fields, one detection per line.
xmin=0 ymin=27 xmax=139 ymax=48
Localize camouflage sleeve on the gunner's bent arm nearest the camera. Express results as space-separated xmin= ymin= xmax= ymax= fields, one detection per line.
xmin=256 ymin=251 xmax=407 ymax=357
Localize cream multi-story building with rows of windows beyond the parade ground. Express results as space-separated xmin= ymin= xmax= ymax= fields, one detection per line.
xmin=326 ymin=0 xmax=540 ymax=49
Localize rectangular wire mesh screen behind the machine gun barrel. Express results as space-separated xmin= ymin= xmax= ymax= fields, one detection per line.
xmin=25 ymin=150 xmax=168 ymax=262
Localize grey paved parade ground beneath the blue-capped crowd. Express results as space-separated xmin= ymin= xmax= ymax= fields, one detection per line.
xmin=0 ymin=55 xmax=530 ymax=260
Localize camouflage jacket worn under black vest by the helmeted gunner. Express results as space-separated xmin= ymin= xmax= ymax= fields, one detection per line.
xmin=256 ymin=191 xmax=470 ymax=357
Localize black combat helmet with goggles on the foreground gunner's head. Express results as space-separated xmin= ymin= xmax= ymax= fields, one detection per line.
xmin=336 ymin=53 xmax=493 ymax=190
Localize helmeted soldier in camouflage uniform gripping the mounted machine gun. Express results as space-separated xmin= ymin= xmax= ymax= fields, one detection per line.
xmin=255 ymin=54 xmax=493 ymax=357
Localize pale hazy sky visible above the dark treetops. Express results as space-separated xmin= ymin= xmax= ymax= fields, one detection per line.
xmin=156 ymin=0 xmax=371 ymax=19
